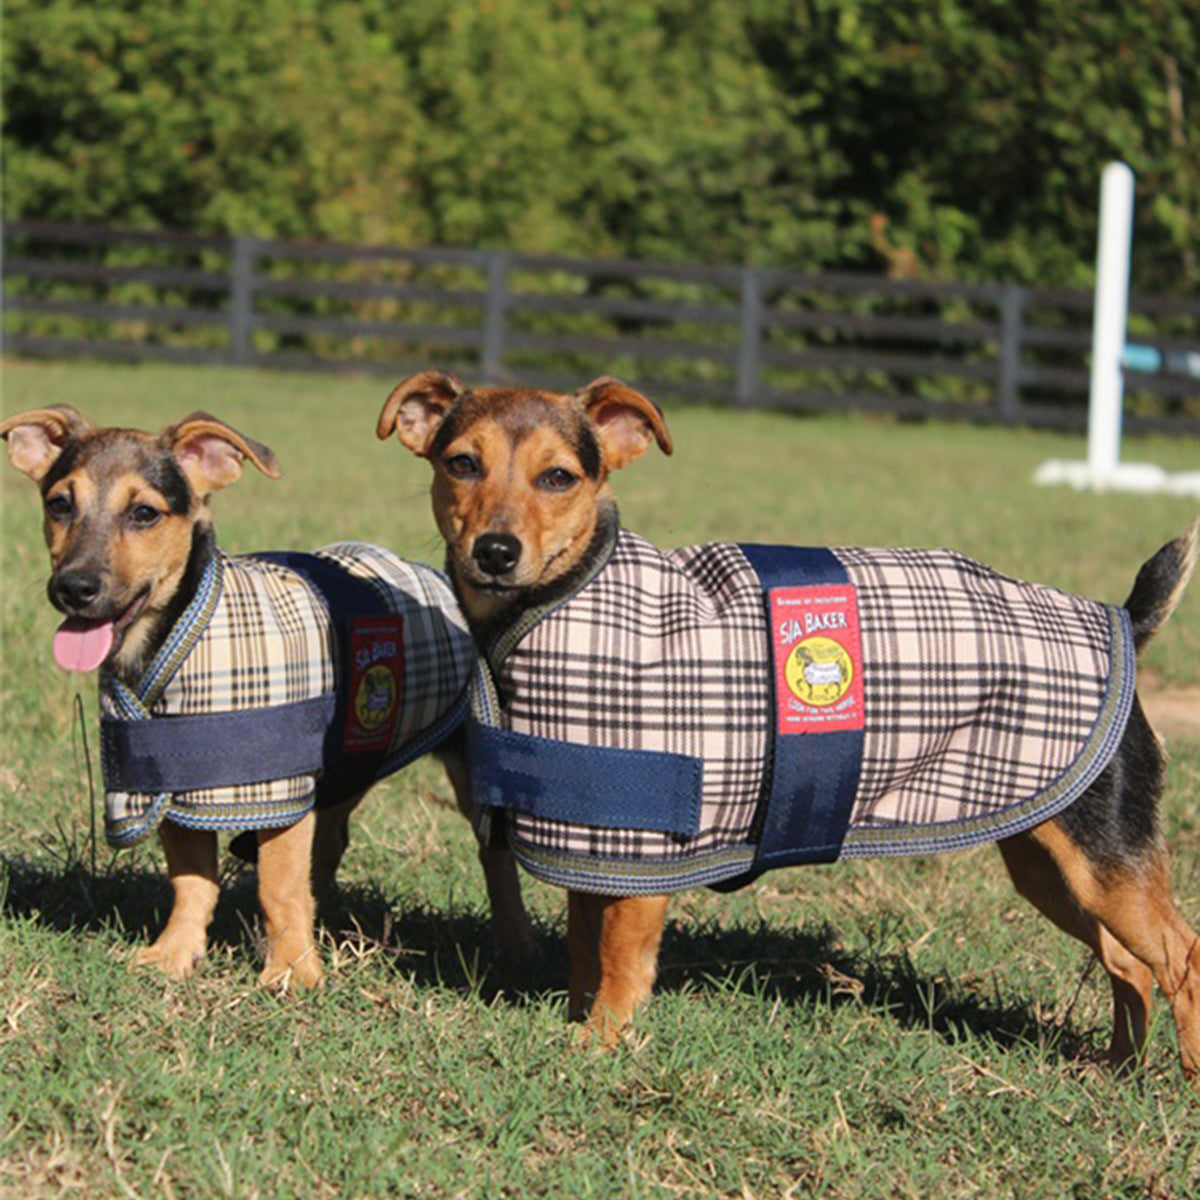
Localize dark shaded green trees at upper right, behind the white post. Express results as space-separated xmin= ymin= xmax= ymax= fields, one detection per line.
xmin=757 ymin=0 xmax=1200 ymax=288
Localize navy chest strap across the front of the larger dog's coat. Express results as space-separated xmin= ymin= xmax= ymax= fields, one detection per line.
xmin=467 ymin=720 xmax=704 ymax=840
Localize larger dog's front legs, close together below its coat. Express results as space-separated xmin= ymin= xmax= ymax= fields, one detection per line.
xmin=566 ymin=892 xmax=667 ymax=1046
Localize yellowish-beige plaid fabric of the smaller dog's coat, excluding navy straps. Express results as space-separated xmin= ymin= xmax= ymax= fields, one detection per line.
xmin=100 ymin=542 xmax=474 ymax=846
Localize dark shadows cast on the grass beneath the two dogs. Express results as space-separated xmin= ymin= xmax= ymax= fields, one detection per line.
xmin=0 ymin=858 xmax=1100 ymax=1062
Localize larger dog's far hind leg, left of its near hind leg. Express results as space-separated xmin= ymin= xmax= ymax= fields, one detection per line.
xmin=1000 ymin=834 xmax=1154 ymax=1068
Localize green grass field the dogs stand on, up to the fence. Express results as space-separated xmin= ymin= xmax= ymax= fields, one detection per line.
xmin=0 ymin=364 xmax=1200 ymax=1200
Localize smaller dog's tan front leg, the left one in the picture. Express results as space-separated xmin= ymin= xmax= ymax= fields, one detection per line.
xmin=133 ymin=821 xmax=218 ymax=979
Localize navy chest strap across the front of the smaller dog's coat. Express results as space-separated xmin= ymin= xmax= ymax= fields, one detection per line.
xmin=100 ymin=695 xmax=334 ymax=796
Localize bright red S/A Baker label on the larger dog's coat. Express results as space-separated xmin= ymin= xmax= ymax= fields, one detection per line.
xmin=770 ymin=583 xmax=863 ymax=734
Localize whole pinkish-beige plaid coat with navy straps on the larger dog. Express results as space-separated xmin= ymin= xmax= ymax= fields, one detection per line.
xmin=469 ymin=530 xmax=1134 ymax=895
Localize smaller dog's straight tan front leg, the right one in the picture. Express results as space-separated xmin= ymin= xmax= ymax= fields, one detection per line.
xmin=258 ymin=812 xmax=323 ymax=988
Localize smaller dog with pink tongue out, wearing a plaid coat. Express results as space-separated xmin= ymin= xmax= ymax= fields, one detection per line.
xmin=0 ymin=406 xmax=529 ymax=986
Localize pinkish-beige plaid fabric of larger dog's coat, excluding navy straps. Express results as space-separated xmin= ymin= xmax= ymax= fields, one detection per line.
xmin=477 ymin=530 xmax=1133 ymax=890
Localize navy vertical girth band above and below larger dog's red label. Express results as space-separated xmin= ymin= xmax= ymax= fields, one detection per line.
xmin=736 ymin=545 xmax=864 ymax=886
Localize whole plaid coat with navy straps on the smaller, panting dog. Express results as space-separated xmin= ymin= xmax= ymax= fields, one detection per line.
xmin=100 ymin=542 xmax=475 ymax=846
